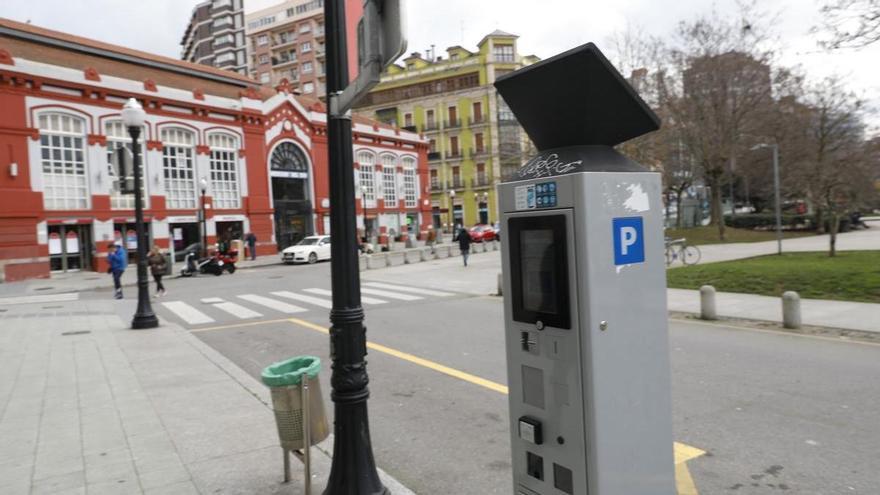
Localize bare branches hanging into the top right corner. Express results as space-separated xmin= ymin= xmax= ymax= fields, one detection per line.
xmin=812 ymin=0 xmax=880 ymax=50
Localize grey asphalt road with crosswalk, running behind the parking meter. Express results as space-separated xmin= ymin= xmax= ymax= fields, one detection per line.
xmin=96 ymin=263 xmax=880 ymax=495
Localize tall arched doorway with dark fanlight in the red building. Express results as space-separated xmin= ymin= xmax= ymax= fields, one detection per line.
xmin=269 ymin=141 xmax=314 ymax=250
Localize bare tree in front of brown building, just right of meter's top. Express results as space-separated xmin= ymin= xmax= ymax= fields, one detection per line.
xmin=658 ymin=4 xmax=788 ymax=240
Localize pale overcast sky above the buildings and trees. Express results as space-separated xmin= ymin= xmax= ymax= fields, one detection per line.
xmin=0 ymin=0 xmax=880 ymax=132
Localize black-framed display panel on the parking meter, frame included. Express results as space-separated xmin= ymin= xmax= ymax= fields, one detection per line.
xmin=506 ymin=213 xmax=571 ymax=329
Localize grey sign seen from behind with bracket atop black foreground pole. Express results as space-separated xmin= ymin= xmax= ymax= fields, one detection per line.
xmin=329 ymin=0 xmax=406 ymax=116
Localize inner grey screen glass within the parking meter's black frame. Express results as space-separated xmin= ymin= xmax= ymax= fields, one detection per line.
xmin=519 ymin=229 xmax=559 ymax=314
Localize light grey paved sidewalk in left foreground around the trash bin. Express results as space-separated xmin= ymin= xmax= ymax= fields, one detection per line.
xmin=0 ymin=301 xmax=411 ymax=495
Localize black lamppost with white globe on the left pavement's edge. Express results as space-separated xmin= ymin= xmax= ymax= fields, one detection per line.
xmin=122 ymin=98 xmax=159 ymax=330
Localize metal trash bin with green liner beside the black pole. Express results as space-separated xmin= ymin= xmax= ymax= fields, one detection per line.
xmin=262 ymin=356 xmax=330 ymax=486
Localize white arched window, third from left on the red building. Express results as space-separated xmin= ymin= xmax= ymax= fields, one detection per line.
xmin=161 ymin=127 xmax=196 ymax=209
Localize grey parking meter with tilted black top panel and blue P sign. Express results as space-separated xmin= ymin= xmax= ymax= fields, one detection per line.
xmin=495 ymin=44 xmax=676 ymax=495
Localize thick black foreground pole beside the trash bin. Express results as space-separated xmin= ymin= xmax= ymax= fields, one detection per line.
xmin=324 ymin=0 xmax=389 ymax=495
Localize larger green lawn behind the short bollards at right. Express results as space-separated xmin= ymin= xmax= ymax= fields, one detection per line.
xmin=667 ymin=251 xmax=880 ymax=303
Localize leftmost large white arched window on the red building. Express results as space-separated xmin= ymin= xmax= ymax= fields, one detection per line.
xmin=37 ymin=113 xmax=89 ymax=210
